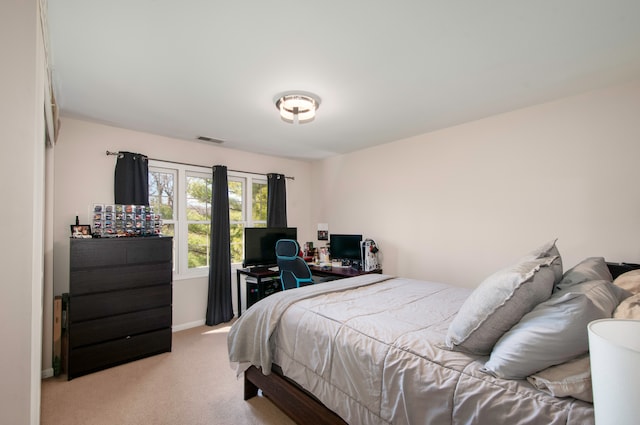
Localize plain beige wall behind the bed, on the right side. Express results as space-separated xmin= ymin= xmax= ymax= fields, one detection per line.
xmin=312 ymin=81 xmax=640 ymax=287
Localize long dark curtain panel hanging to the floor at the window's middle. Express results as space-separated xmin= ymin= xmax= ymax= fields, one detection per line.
xmin=206 ymin=165 xmax=233 ymax=326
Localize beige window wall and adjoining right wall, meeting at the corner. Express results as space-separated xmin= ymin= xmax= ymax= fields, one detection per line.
xmin=54 ymin=82 xmax=640 ymax=329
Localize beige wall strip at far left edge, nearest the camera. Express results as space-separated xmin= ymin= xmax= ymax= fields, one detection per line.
xmin=0 ymin=0 xmax=45 ymax=425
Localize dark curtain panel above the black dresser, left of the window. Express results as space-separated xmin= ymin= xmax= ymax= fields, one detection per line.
xmin=113 ymin=152 xmax=149 ymax=205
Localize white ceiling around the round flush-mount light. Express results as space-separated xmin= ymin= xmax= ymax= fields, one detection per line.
xmin=48 ymin=0 xmax=640 ymax=159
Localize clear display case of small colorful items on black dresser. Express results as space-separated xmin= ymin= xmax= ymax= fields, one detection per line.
xmin=91 ymin=204 xmax=162 ymax=238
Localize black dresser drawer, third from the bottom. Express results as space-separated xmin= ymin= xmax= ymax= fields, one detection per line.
xmin=69 ymin=283 xmax=171 ymax=324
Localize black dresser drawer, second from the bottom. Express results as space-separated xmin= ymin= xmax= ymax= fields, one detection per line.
xmin=69 ymin=306 xmax=171 ymax=348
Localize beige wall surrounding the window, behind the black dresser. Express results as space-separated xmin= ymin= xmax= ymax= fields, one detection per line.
xmin=53 ymin=118 xmax=313 ymax=329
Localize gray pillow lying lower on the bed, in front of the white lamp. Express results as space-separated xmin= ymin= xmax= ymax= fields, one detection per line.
xmin=483 ymin=280 xmax=618 ymax=379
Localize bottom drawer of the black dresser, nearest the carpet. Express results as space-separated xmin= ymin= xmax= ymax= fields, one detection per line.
xmin=68 ymin=329 xmax=171 ymax=379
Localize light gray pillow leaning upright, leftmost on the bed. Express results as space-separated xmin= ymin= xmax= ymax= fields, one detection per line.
xmin=445 ymin=256 xmax=561 ymax=355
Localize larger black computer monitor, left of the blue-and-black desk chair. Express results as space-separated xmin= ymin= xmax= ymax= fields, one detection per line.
xmin=243 ymin=227 xmax=298 ymax=267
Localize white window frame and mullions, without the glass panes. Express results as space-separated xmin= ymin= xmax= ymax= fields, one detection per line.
xmin=149 ymin=159 xmax=267 ymax=280
